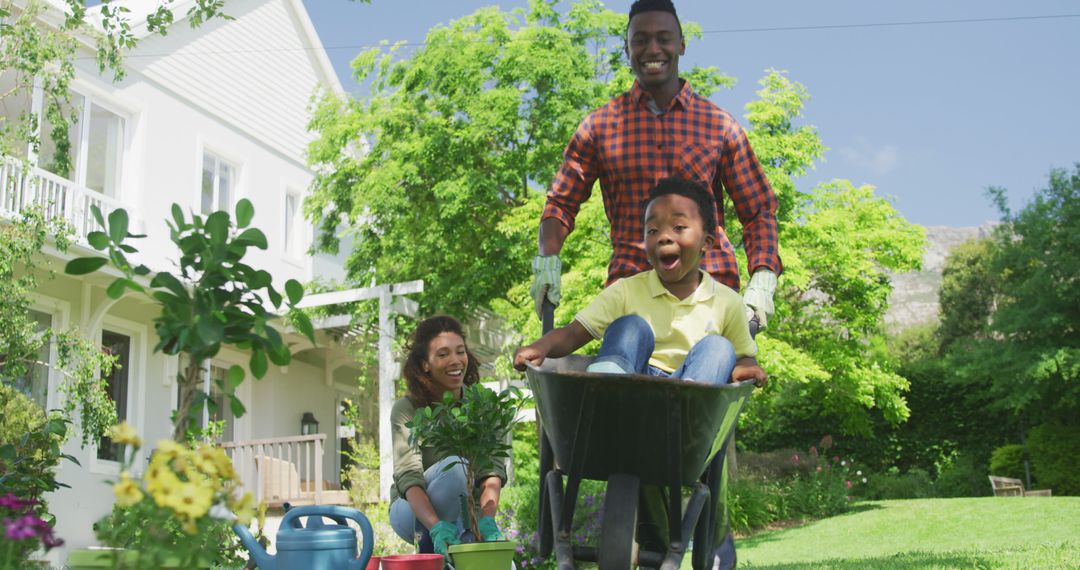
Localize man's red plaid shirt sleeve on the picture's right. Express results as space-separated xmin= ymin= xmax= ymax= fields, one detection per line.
xmin=719 ymin=120 xmax=783 ymax=275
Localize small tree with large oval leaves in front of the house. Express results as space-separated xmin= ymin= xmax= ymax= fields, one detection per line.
xmin=65 ymin=199 xmax=315 ymax=440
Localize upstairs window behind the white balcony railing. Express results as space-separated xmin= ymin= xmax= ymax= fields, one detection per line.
xmin=38 ymin=93 xmax=125 ymax=198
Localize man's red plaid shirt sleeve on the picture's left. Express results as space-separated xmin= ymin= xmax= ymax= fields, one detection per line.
xmin=540 ymin=116 xmax=599 ymax=231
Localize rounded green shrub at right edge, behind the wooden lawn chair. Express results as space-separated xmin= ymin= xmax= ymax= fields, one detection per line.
xmin=1027 ymin=423 xmax=1080 ymax=494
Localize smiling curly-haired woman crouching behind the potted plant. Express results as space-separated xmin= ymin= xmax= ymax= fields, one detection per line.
xmin=390 ymin=316 xmax=507 ymax=554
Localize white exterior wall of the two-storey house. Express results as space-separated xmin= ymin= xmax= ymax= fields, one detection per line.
xmin=22 ymin=0 xmax=354 ymax=566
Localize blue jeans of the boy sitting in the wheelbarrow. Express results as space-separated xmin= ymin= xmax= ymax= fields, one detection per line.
xmin=594 ymin=315 xmax=737 ymax=385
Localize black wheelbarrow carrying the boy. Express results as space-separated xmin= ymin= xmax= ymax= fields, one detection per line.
xmin=526 ymin=355 xmax=754 ymax=570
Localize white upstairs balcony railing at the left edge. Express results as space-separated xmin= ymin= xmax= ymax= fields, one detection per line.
xmin=0 ymin=157 xmax=130 ymax=244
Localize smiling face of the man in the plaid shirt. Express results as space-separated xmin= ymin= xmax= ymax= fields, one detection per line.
xmin=625 ymin=12 xmax=686 ymax=90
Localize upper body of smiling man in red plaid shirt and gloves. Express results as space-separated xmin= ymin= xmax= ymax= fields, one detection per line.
xmin=530 ymin=0 xmax=782 ymax=327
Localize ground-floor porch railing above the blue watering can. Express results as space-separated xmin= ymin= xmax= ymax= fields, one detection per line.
xmin=221 ymin=434 xmax=326 ymax=506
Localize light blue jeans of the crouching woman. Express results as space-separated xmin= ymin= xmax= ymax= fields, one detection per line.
xmin=390 ymin=456 xmax=469 ymax=552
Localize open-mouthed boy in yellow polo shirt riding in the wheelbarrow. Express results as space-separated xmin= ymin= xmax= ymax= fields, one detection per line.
xmin=514 ymin=178 xmax=768 ymax=385
